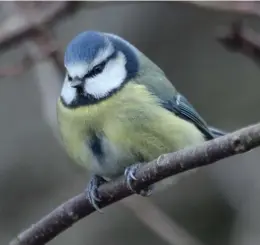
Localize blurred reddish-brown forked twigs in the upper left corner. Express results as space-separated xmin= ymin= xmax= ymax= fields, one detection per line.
xmin=0 ymin=2 xmax=77 ymax=77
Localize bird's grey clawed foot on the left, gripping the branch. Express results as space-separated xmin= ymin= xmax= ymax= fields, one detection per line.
xmin=85 ymin=175 xmax=107 ymax=213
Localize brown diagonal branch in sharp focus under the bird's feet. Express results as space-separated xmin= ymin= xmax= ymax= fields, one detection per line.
xmin=10 ymin=124 xmax=260 ymax=245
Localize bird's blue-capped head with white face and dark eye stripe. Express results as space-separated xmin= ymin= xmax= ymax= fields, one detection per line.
xmin=61 ymin=31 xmax=139 ymax=107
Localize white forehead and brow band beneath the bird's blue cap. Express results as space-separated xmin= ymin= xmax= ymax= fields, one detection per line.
xmin=66 ymin=43 xmax=115 ymax=77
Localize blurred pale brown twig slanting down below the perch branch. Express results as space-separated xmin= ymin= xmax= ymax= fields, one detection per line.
xmin=123 ymin=196 xmax=203 ymax=245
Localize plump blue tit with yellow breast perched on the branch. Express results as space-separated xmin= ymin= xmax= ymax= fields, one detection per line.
xmin=57 ymin=31 xmax=224 ymax=209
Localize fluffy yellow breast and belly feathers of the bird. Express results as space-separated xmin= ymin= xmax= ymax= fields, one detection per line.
xmin=57 ymin=83 xmax=204 ymax=177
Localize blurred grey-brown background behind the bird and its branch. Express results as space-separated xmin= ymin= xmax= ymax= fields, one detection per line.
xmin=0 ymin=2 xmax=260 ymax=245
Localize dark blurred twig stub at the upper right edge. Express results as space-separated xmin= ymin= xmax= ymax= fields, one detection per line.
xmin=218 ymin=21 xmax=260 ymax=64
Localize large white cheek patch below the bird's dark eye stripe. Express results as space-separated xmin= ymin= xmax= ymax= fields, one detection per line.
xmin=84 ymin=52 xmax=127 ymax=98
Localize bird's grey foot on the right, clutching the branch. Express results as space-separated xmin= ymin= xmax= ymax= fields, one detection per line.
xmin=124 ymin=163 xmax=153 ymax=197
